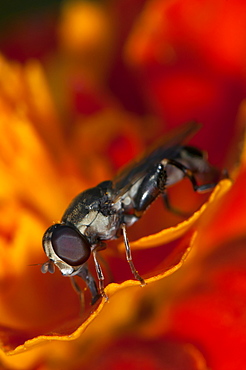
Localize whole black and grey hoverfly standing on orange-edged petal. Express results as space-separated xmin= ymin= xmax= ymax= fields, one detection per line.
xmin=42 ymin=122 xmax=219 ymax=304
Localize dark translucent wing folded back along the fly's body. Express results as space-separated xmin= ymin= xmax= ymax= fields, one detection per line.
xmin=113 ymin=122 xmax=200 ymax=199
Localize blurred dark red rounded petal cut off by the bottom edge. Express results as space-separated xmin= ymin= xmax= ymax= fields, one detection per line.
xmin=88 ymin=335 xmax=208 ymax=370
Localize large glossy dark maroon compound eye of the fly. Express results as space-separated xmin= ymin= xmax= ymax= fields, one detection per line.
xmin=51 ymin=225 xmax=91 ymax=266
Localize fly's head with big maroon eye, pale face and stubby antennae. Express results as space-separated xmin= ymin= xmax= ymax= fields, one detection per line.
xmin=41 ymin=224 xmax=91 ymax=276
